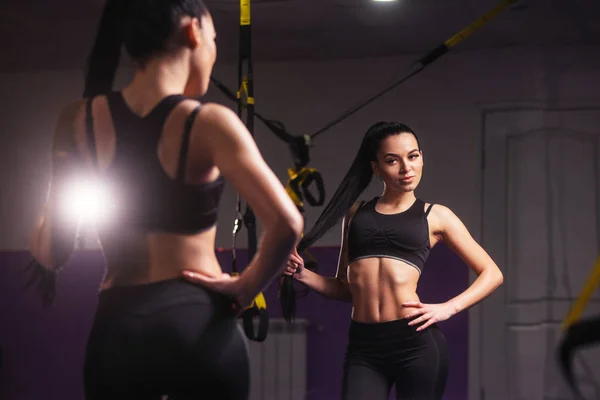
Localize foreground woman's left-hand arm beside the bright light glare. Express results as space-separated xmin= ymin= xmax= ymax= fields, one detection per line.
xmin=30 ymin=102 xmax=84 ymax=270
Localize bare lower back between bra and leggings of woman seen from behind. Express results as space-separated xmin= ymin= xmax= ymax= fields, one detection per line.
xmin=100 ymin=227 xmax=222 ymax=289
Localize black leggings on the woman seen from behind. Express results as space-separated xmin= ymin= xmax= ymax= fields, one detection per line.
xmin=84 ymin=279 xmax=250 ymax=400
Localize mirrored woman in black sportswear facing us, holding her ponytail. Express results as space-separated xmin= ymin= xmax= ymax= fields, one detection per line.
xmin=285 ymin=122 xmax=503 ymax=400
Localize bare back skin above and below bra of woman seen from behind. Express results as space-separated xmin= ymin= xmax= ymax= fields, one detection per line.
xmin=75 ymin=96 xmax=230 ymax=289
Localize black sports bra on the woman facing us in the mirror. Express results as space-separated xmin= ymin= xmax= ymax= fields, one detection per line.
xmin=348 ymin=197 xmax=433 ymax=273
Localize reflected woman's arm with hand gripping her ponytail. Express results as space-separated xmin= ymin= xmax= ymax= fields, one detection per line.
xmin=288 ymin=204 xmax=358 ymax=302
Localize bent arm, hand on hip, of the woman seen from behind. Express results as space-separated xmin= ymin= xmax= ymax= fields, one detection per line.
xmin=188 ymin=104 xmax=304 ymax=306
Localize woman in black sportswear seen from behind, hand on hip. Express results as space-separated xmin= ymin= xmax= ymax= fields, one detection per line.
xmin=31 ymin=0 xmax=303 ymax=400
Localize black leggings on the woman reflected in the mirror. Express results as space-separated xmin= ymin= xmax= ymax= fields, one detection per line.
xmin=342 ymin=320 xmax=448 ymax=400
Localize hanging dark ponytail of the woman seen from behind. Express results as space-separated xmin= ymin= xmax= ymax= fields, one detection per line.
xmin=83 ymin=0 xmax=127 ymax=97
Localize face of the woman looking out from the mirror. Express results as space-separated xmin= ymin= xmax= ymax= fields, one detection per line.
xmin=371 ymin=132 xmax=423 ymax=192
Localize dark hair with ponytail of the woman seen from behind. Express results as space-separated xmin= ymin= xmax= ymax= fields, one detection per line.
xmin=83 ymin=0 xmax=208 ymax=97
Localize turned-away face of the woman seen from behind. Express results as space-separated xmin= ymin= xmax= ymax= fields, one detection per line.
xmin=185 ymin=13 xmax=217 ymax=97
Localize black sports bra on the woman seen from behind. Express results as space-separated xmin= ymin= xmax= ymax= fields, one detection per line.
xmin=86 ymin=92 xmax=224 ymax=234
